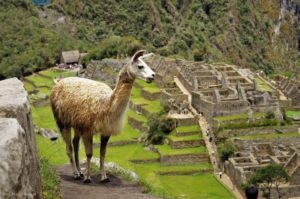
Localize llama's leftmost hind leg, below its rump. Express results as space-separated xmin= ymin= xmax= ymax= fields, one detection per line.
xmin=61 ymin=128 xmax=80 ymax=179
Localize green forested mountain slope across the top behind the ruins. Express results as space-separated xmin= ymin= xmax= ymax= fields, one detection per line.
xmin=0 ymin=0 xmax=300 ymax=76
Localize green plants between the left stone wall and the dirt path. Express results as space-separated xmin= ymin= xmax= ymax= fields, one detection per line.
xmin=40 ymin=158 xmax=61 ymax=199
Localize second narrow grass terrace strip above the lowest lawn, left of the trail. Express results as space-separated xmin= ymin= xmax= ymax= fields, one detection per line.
xmin=158 ymin=145 xmax=207 ymax=155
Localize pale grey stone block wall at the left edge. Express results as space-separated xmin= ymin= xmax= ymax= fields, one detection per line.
xmin=0 ymin=78 xmax=41 ymax=198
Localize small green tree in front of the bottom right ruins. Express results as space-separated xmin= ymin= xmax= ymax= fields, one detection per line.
xmin=248 ymin=164 xmax=289 ymax=199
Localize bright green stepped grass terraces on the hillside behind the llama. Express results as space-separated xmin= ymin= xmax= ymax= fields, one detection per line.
xmin=25 ymin=70 xmax=233 ymax=199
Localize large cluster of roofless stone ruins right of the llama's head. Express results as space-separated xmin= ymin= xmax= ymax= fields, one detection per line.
xmin=149 ymin=56 xmax=279 ymax=121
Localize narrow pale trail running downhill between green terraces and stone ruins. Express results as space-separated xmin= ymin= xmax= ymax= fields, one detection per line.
xmin=174 ymin=77 xmax=244 ymax=199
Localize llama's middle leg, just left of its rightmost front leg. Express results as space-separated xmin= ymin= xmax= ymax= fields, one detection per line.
xmin=83 ymin=136 xmax=93 ymax=183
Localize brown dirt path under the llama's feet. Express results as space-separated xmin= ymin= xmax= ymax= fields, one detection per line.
xmin=57 ymin=165 xmax=157 ymax=199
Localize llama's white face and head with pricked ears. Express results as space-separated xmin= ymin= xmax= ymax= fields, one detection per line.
xmin=127 ymin=50 xmax=155 ymax=83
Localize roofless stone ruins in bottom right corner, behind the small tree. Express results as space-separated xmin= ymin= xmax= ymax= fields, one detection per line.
xmin=224 ymin=143 xmax=300 ymax=198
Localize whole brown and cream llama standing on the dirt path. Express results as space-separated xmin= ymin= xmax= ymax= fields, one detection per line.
xmin=50 ymin=50 xmax=155 ymax=183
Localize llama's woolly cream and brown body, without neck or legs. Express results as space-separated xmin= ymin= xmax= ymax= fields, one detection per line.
xmin=50 ymin=77 xmax=112 ymax=133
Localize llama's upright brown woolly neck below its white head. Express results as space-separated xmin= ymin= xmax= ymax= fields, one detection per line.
xmin=109 ymin=70 xmax=134 ymax=119
